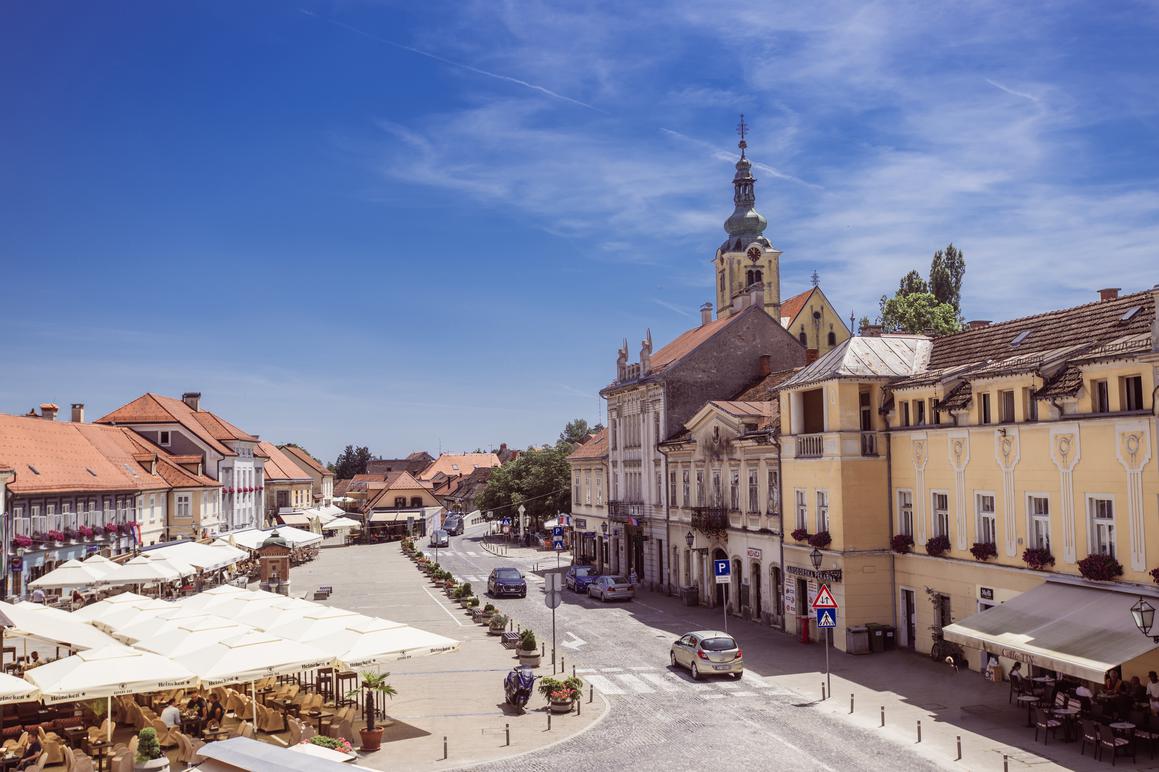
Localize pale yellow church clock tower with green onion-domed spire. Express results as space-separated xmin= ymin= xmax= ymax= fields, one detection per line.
xmin=713 ymin=115 xmax=781 ymax=323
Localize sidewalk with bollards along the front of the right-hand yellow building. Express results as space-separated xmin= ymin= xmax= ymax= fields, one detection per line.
xmin=636 ymin=590 xmax=1159 ymax=771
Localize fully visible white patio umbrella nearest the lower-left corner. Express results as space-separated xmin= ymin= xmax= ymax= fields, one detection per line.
xmin=27 ymin=643 xmax=197 ymax=743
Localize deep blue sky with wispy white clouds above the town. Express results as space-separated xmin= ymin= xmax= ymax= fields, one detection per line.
xmin=0 ymin=0 xmax=1159 ymax=460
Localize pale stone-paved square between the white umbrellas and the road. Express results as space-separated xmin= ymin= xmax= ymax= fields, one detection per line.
xmin=291 ymin=542 xmax=607 ymax=770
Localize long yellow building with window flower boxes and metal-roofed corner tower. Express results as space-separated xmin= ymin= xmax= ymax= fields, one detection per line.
xmin=780 ymin=285 xmax=1159 ymax=680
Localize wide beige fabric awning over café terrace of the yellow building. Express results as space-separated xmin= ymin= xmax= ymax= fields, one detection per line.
xmin=942 ymin=582 xmax=1157 ymax=683
